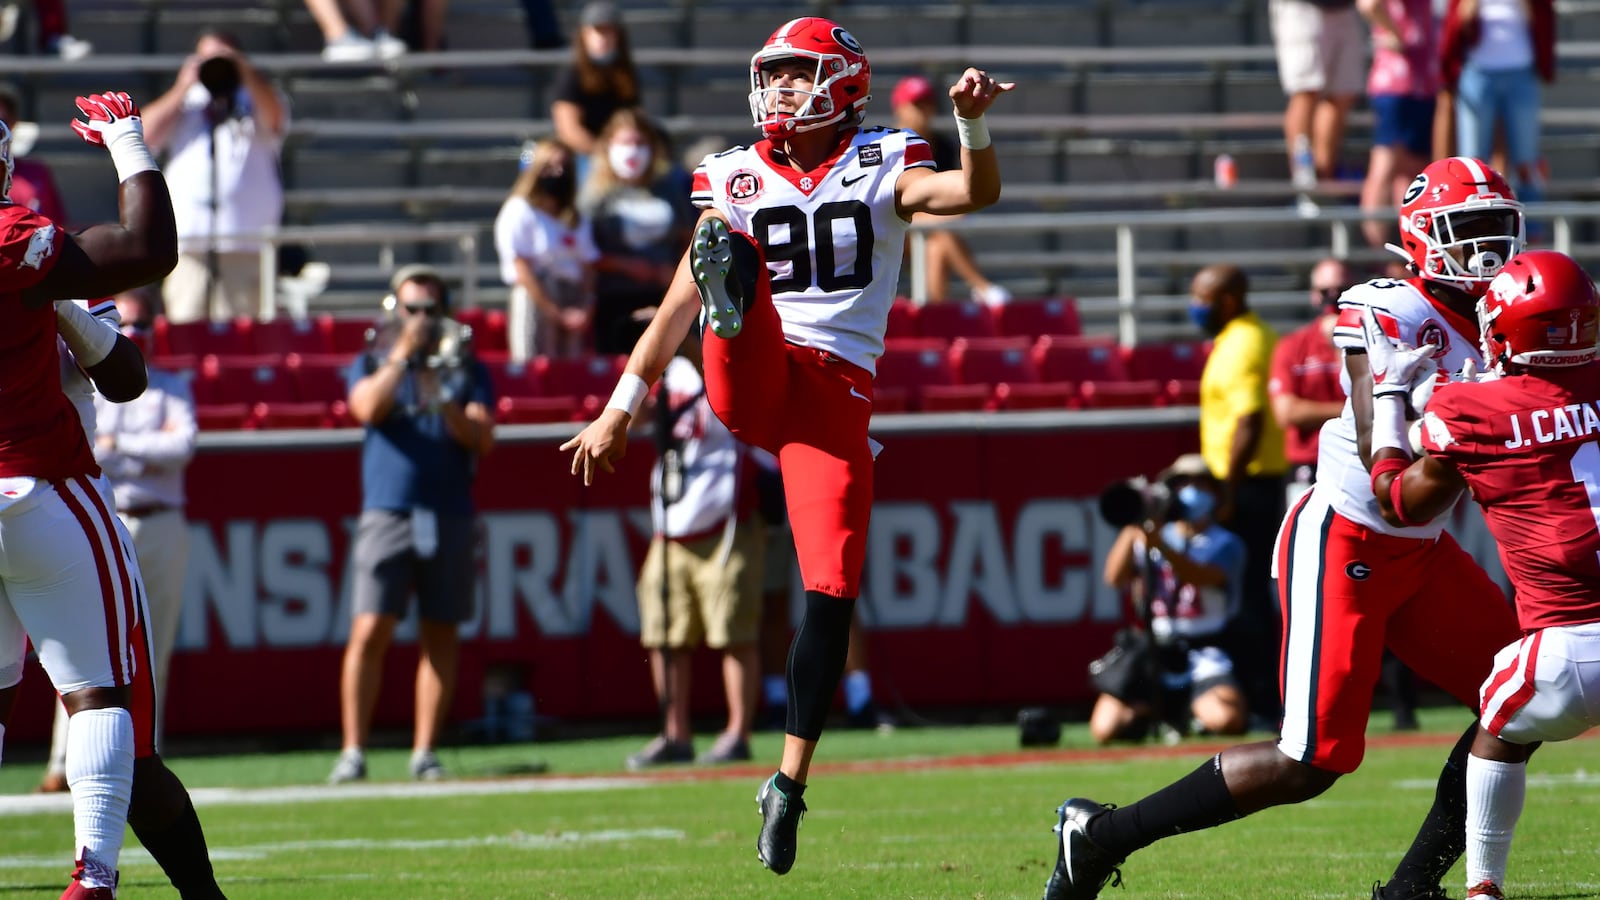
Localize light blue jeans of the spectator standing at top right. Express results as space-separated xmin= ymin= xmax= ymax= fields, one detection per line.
xmin=1456 ymin=66 xmax=1544 ymax=203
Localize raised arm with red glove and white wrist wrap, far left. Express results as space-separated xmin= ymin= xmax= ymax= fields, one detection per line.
xmin=24 ymin=91 xmax=178 ymax=306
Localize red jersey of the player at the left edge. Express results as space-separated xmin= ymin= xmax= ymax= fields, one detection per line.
xmin=0 ymin=203 xmax=99 ymax=479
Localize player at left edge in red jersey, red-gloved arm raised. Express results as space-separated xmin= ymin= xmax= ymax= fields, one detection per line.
xmin=0 ymin=93 xmax=227 ymax=898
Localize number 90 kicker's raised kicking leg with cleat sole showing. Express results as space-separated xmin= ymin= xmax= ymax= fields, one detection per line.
xmin=690 ymin=218 xmax=795 ymax=453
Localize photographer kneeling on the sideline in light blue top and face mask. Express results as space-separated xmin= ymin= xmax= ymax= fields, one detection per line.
xmin=1090 ymin=453 xmax=1250 ymax=743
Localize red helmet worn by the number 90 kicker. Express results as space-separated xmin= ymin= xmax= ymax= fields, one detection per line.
xmin=750 ymin=16 xmax=872 ymax=138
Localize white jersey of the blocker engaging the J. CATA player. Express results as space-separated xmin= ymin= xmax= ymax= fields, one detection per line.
xmin=1312 ymin=279 xmax=1482 ymax=538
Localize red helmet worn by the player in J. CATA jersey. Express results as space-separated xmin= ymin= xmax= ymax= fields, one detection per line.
xmin=1478 ymin=250 xmax=1600 ymax=372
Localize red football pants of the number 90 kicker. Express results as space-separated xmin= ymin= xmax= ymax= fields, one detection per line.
xmin=702 ymin=232 xmax=872 ymax=599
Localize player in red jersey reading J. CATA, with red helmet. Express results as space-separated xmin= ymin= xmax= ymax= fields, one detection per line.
xmin=1373 ymin=250 xmax=1600 ymax=897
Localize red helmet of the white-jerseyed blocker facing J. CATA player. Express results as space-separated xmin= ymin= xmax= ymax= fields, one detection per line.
xmin=1389 ymin=157 xmax=1523 ymax=296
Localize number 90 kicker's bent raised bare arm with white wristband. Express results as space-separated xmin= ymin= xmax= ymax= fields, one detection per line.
xmin=894 ymin=69 xmax=1016 ymax=219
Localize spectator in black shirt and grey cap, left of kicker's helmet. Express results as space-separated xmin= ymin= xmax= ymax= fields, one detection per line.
xmin=550 ymin=0 xmax=638 ymax=162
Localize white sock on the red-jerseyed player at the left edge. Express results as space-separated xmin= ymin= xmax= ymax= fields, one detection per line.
xmin=67 ymin=709 xmax=133 ymax=887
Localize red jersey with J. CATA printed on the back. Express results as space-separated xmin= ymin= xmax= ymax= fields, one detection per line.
xmin=1422 ymin=362 xmax=1600 ymax=631
